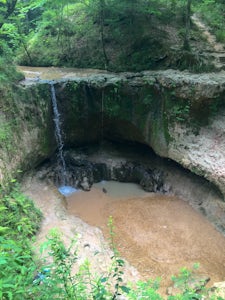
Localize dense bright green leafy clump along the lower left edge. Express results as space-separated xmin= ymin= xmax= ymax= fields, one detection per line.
xmin=0 ymin=180 xmax=41 ymax=299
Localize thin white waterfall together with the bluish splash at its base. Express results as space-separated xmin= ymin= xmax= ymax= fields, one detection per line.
xmin=50 ymin=83 xmax=77 ymax=196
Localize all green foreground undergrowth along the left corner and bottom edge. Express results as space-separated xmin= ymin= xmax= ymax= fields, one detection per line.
xmin=0 ymin=186 xmax=222 ymax=300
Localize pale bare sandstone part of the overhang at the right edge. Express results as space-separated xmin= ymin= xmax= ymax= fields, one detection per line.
xmin=168 ymin=111 xmax=225 ymax=200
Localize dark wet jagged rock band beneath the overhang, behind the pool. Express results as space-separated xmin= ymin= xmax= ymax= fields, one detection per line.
xmin=39 ymin=150 xmax=163 ymax=192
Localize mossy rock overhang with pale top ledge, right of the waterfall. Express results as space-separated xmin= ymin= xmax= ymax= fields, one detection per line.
xmin=13 ymin=68 xmax=225 ymax=199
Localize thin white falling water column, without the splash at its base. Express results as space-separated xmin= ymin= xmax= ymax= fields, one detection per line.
xmin=51 ymin=83 xmax=66 ymax=186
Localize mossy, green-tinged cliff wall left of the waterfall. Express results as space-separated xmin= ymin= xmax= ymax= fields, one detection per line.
xmin=0 ymin=85 xmax=54 ymax=186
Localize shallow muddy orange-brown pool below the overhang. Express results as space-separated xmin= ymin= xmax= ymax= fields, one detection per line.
xmin=66 ymin=182 xmax=225 ymax=285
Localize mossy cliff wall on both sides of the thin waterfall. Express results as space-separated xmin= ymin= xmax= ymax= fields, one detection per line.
xmin=1 ymin=70 xmax=225 ymax=199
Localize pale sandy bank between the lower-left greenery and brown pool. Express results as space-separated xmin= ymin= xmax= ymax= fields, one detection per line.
xmin=22 ymin=177 xmax=141 ymax=283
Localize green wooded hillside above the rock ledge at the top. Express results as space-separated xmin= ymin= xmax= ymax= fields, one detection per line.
xmin=0 ymin=0 xmax=225 ymax=71
